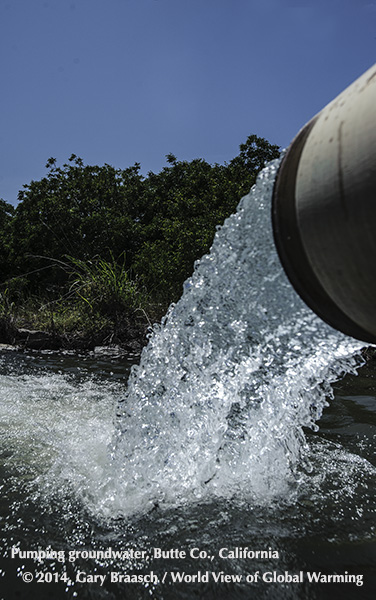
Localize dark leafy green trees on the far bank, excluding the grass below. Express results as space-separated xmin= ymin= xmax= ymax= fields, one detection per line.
xmin=0 ymin=135 xmax=279 ymax=328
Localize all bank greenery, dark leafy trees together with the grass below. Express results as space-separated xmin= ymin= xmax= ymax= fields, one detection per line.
xmin=0 ymin=135 xmax=279 ymax=350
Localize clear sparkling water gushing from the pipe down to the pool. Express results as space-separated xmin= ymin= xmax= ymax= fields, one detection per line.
xmin=101 ymin=161 xmax=362 ymax=514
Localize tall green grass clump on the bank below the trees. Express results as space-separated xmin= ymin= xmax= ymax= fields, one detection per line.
xmin=0 ymin=256 xmax=162 ymax=344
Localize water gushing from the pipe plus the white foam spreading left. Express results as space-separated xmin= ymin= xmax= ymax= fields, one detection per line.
xmin=2 ymin=162 xmax=361 ymax=517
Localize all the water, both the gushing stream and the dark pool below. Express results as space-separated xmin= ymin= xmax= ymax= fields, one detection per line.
xmin=0 ymin=163 xmax=376 ymax=600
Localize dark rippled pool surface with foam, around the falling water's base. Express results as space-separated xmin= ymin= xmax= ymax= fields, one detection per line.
xmin=0 ymin=351 xmax=376 ymax=599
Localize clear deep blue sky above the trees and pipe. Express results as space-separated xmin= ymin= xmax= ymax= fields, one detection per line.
xmin=0 ymin=0 xmax=376 ymax=204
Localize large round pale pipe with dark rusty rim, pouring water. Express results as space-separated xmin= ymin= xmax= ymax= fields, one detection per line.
xmin=272 ymin=65 xmax=376 ymax=343
